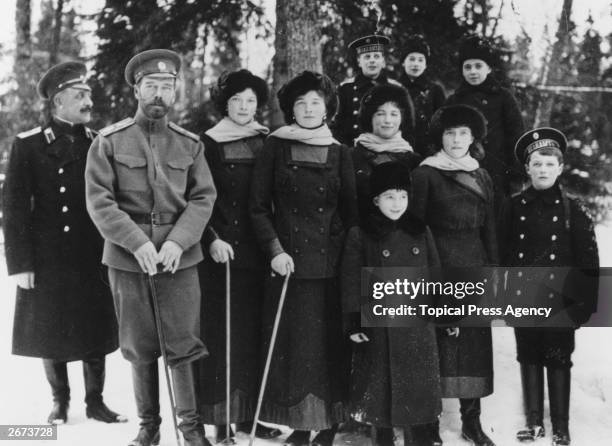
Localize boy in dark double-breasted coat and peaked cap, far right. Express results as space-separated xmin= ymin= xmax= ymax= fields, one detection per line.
xmin=500 ymin=128 xmax=599 ymax=446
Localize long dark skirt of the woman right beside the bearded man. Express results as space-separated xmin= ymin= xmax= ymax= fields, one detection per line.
xmin=198 ymin=259 xmax=265 ymax=424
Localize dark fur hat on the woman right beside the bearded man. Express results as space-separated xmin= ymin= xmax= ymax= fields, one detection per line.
xmin=210 ymin=70 xmax=268 ymax=116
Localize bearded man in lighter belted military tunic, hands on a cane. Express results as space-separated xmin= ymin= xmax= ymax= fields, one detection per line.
xmin=85 ymin=49 xmax=216 ymax=446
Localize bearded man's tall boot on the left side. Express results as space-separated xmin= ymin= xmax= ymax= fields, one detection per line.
xmin=128 ymin=361 xmax=161 ymax=446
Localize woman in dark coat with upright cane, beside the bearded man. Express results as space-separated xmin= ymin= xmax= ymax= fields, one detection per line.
xmin=199 ymin=70 xmax=280 ymax=441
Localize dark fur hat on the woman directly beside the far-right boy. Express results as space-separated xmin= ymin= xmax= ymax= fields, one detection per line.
xmin=429 ymin=104 xmax=487 ymax=142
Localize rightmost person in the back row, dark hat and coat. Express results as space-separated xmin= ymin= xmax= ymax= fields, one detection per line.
xmin=446 ymin=36 xmax=523 ymax=209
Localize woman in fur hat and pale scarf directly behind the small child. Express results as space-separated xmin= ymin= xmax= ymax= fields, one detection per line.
xmin=353 ymin=84 xmax=422 ymax=221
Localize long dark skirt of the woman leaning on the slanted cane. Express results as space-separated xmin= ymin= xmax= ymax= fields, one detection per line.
xmin=261 ymin=276 xmax=348 ymax=430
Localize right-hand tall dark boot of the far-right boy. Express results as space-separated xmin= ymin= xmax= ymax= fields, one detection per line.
xmin=546 ymin=367 xmax=571 ymax=446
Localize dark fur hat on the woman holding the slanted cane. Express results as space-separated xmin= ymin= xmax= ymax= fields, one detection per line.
xmin=276 ymin=71 xmax=338 ymax=124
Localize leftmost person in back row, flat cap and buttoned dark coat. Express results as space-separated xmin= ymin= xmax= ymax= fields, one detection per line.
xmin=331 ymin=34 xmax=401 ymax=147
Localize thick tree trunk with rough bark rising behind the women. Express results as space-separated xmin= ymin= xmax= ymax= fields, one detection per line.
xmin=271 ymin=0 xmax=323 ymax=127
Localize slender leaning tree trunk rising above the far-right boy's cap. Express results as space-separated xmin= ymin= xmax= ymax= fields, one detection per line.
xmin=534 ymin=0 xmax=573 ymax=127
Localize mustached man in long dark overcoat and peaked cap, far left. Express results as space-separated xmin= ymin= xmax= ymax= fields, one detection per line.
xmin=4 ymin=62 xmax=125 ymax=424
